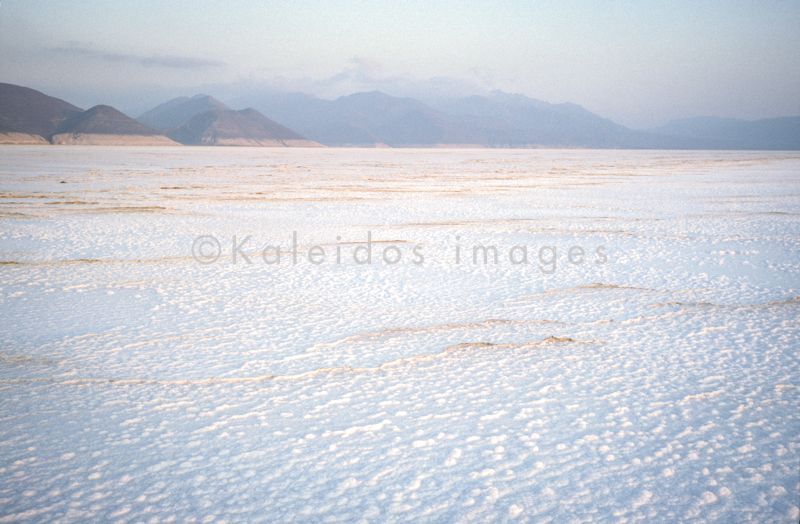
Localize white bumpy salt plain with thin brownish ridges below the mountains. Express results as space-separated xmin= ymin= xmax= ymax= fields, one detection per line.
xmin=0 ymin=146 xmax=800 ymax=523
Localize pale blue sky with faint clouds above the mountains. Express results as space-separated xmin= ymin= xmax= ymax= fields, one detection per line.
xmin=0 ymin=0 xmax=800 ymax=127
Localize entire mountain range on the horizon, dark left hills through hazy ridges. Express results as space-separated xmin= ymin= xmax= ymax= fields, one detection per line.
xmin=0 ymin=84 xmax=800 ymax=150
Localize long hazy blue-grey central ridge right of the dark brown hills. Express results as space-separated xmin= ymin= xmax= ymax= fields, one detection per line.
xmin=238 ymin=91 xmax=788 ymax=149
